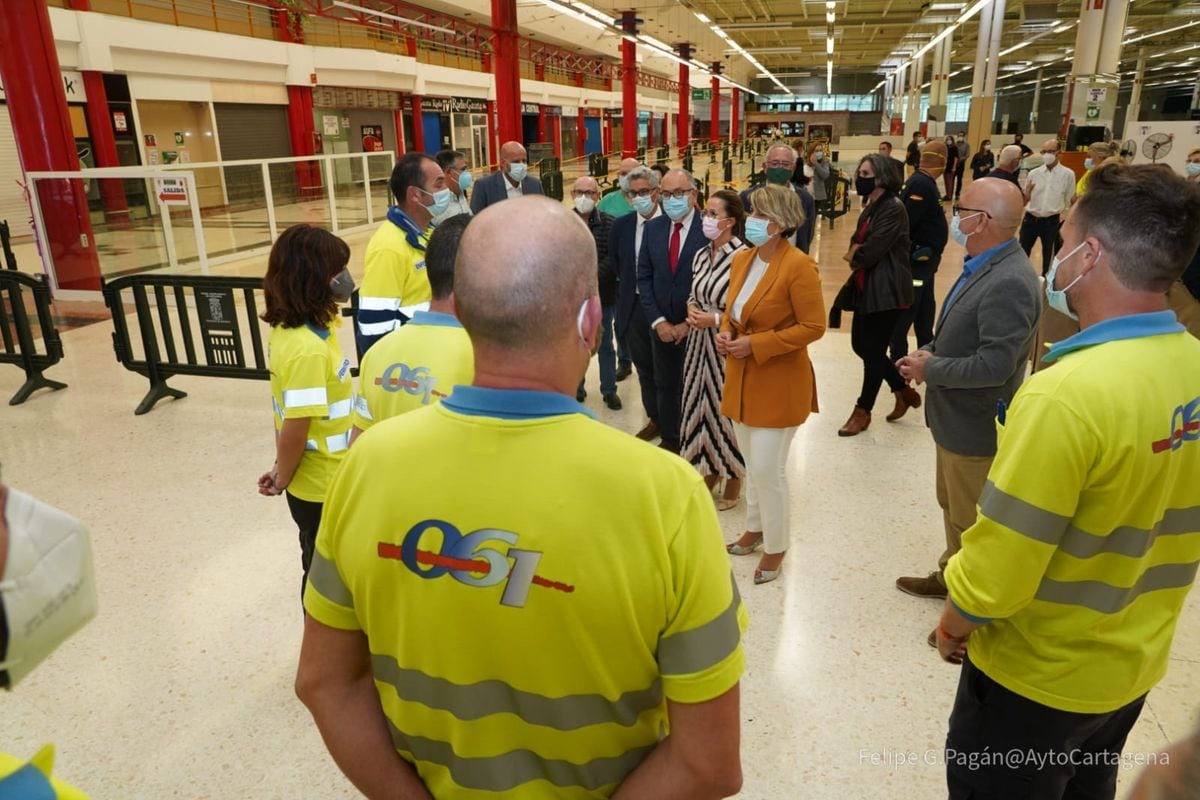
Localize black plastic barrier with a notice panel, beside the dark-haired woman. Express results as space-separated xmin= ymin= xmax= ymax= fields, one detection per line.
xmin=103 ymin=275 xmax=271 ymax=414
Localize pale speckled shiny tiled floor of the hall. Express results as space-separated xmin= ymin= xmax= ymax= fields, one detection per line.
xmin=0 ymin=172 xmax=1200 ymax=800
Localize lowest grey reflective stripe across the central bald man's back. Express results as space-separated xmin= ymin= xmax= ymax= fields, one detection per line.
xmin=388 ymin=720 xmax=658 ymax=796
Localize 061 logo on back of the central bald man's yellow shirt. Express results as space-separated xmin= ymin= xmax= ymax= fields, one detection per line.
xmin=377 ymin=519 xmax=575 ymax=608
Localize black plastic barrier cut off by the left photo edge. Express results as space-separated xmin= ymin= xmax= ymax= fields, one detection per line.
xmin=0 ymin=270 xmax=67 ymax=405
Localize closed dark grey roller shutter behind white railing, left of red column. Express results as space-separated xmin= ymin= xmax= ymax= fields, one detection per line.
xmin=212 ymin=103 xmax=296 ymax=206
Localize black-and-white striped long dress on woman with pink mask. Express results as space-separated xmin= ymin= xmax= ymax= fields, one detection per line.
xmin=679 ymin=237 xmax=745 ymax=479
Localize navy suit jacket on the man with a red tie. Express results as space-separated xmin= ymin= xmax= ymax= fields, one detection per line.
xmin=625 ymin=210 xmax=708 ymax=325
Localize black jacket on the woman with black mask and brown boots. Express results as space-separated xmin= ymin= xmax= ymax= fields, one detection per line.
xmin=850 ymin=194 xmax=913 ymax=314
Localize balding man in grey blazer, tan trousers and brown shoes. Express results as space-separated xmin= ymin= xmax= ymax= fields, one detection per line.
xmin=896 ymin=181 xmax=1042 ymax=638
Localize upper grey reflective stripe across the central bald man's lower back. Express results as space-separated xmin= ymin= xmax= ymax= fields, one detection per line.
xmin=369 ymin=652 xmax=662 ymax=730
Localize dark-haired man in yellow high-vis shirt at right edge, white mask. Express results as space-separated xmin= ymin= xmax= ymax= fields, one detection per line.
xmin=937 ymin=164 xmax=1200 ymax=800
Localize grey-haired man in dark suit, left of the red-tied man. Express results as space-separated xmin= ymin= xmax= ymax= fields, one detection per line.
xmin=608 ymin=167 xmax=662 ymax=441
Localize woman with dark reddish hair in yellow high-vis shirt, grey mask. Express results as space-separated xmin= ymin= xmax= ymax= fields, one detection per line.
xmin=258 ymin=224 xmax=354 ymax=596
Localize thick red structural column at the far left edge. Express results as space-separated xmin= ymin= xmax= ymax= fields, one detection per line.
xmin=0 ymin=0 xmax=100 ymax=290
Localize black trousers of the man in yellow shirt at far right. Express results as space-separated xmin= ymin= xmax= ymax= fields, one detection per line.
xmin=946 ymin=657 xmax=1146 ymax=800
